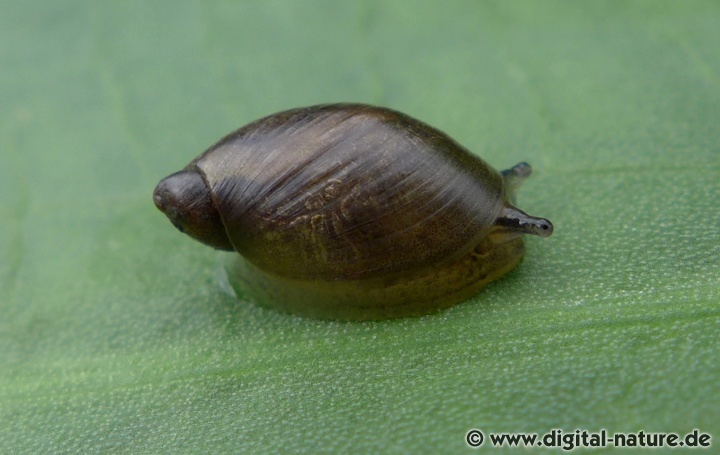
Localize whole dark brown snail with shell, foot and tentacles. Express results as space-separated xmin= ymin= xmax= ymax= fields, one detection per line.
xmin=153 ymin=104 xmax=553 ymax=320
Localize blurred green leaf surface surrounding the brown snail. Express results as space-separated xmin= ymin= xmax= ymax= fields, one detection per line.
xmin=0 ymin=0 xmax=720 ymax=453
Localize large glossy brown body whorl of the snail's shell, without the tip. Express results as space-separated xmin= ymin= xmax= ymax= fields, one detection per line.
xmin=193 ymin=104 xmax=504 ymax=280
